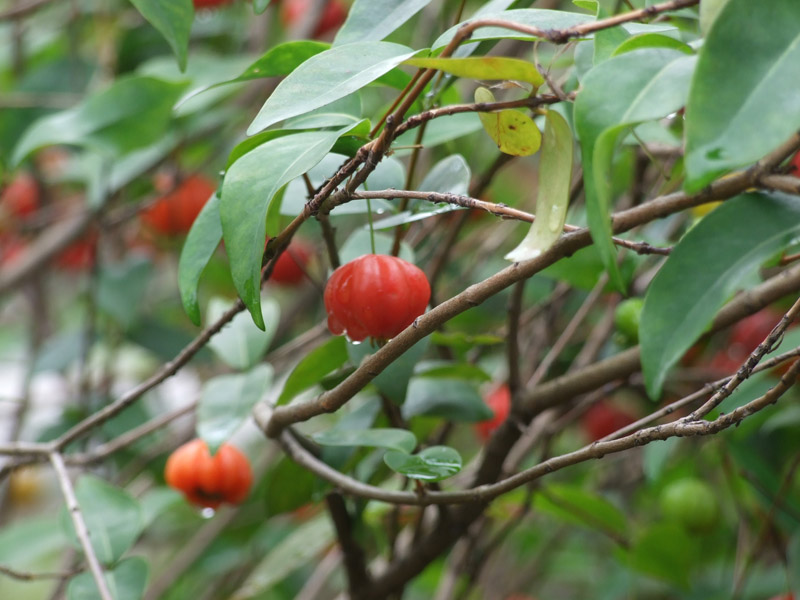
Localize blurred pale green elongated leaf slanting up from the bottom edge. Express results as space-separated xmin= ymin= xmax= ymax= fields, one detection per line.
xmin=231 ymin=516 xmax=336 ymax=600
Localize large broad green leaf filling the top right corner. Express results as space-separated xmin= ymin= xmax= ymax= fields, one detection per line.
xmin=685 ymin=0 xmax=800 ymax=191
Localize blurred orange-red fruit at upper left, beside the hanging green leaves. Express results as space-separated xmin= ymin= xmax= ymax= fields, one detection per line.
xmin=141 ymin=175 xmax=216 ymax=235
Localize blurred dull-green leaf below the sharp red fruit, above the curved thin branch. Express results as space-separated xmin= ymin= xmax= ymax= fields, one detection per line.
xmin=403 ymin=377 xmax=494 ymax=423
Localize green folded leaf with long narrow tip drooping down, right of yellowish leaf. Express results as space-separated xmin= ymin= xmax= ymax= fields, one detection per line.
xmin=575 ymin=49 xmax=693 ymax=290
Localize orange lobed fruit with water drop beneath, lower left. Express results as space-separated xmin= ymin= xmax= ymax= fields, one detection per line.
xmin=164 ymin=438 xmax=253 ymax=508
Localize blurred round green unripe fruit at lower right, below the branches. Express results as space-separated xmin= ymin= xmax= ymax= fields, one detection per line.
xmin=661 ymin=478 xmax=719 ymax=533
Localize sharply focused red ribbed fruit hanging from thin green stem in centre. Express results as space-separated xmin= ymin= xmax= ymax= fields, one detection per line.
xmin=325 ymin=254 xmax=431 ymax=342
